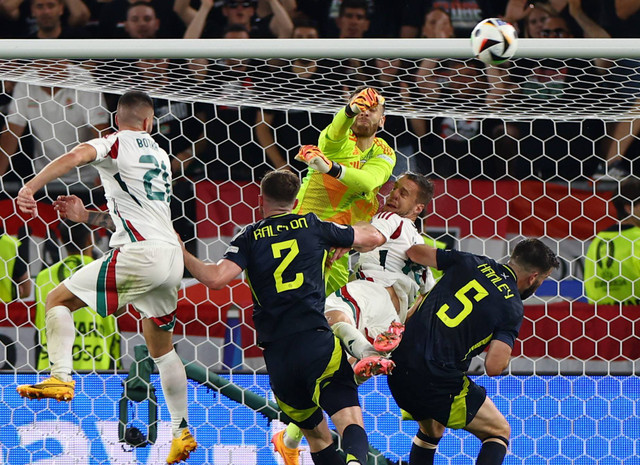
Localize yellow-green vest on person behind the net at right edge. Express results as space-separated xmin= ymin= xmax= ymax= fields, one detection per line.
xmin=584 ymin=224 xmax=640 ymax=305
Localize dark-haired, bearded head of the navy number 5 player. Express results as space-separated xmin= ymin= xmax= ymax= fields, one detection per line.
xmin=509 ymin=239 xmax=560 ymax=300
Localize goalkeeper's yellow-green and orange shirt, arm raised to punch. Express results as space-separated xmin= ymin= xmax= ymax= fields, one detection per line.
xmin=294 ymin=109 xmax=396 ymax=225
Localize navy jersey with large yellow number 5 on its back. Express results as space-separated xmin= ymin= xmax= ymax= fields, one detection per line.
xmin=393 ymin=249 xmax=524 ymax=371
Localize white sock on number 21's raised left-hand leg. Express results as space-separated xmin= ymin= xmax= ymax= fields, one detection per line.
xmin=44 ymin=305 xmax=76 ymax=382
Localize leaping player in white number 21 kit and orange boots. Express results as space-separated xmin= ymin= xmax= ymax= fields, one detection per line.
xmin=17 ymin=92 xmax=196 ymax=463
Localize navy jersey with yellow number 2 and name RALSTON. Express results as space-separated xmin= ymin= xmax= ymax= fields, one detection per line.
xmin=224 ymin=213 xmax=354 ymax=343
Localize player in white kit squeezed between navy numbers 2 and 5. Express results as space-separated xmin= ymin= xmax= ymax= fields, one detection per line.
xmin=325 ymin=173 xmax=435 ymax=379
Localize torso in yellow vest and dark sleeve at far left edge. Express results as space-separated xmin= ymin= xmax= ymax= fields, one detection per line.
xmin=0 ymin=229 xmax=31 ymax=303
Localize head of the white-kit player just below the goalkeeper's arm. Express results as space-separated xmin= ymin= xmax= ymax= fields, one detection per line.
xmin=383 ymin=173 xmax=433 ymax=221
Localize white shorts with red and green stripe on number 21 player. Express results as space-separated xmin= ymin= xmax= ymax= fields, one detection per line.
xmin=63 ymin=241 xmax=184 ymax=331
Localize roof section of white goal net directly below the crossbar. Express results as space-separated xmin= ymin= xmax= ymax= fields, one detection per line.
xmin=0 ymin=58 xmax=640 ymax=120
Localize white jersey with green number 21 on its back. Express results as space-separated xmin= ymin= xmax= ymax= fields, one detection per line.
xmin=87 ymin=131 xmax=179 ymax=247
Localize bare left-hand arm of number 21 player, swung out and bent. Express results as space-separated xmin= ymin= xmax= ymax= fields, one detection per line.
xmin=17 ymin=144 xmax=97 ymax=216
